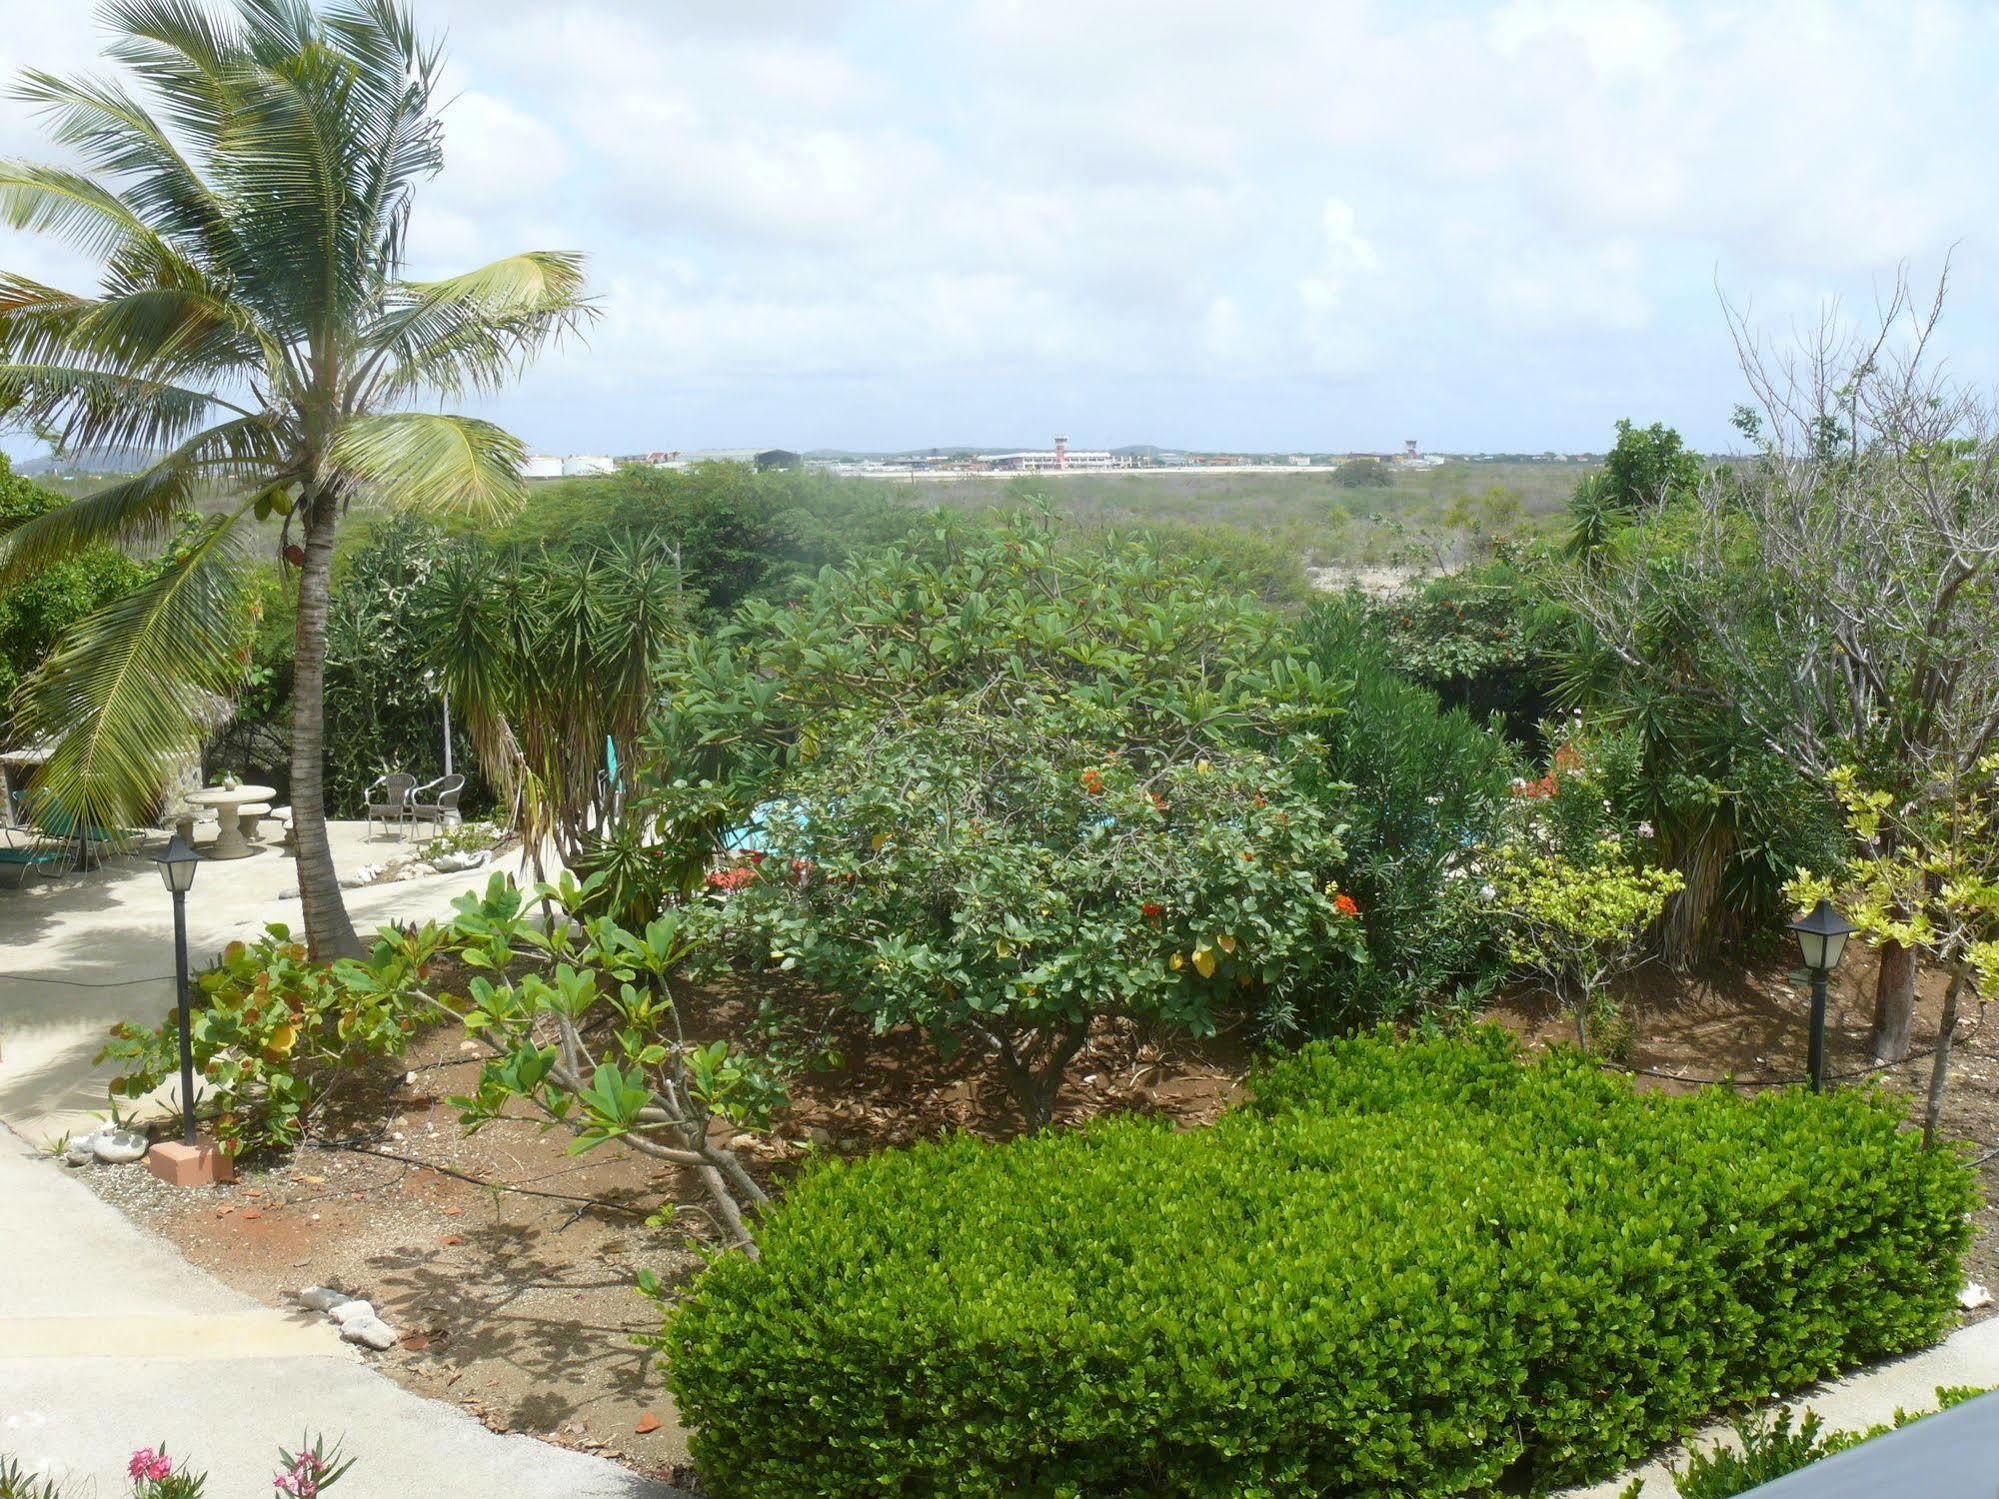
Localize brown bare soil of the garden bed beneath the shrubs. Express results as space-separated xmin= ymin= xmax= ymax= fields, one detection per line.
xmin=84 ymin=951 xmax=1999 ymax=1485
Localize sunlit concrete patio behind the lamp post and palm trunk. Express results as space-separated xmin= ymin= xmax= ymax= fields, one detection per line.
xmin=0 ymin=823 xmax=518 ymax=1145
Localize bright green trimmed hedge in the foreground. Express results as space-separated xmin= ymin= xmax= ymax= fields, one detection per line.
xmin=664 ymin=1031 xmax=1975 ymax=1499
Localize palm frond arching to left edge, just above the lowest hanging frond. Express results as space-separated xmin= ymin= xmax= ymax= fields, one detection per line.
xmin=0 ymin=416 xmax=284 ymax=584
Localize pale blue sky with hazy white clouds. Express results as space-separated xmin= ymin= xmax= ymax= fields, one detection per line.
xmin=0 ymin=0 xmax=1999 ymax=454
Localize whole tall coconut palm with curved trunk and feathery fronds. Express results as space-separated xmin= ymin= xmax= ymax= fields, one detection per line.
xmin=0 ymin=0 xmax=590 ymax=957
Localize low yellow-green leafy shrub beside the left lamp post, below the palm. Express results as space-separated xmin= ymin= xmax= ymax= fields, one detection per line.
xmin=96 ymin=923 xmax=431 ymax=1151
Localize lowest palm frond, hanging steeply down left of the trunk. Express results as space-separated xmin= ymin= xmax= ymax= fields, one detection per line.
xmin=12 ymin=508 xmax=248 ymax=827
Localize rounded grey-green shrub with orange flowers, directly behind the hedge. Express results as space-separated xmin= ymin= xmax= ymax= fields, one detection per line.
xmin=712 ymin=708 xmax=1365 ymax=1127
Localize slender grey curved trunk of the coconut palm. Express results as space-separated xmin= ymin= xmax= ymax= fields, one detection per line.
xmin=292 ymin=492 xmax=362 ymax=963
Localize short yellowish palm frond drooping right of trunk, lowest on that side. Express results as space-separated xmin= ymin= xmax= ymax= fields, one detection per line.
xmin=330 ymin=412 xmax=528 ymax=518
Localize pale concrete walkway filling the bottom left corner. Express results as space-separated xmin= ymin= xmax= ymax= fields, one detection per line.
xmin=0 ymin=1129 xmax=676 ymax=1499
